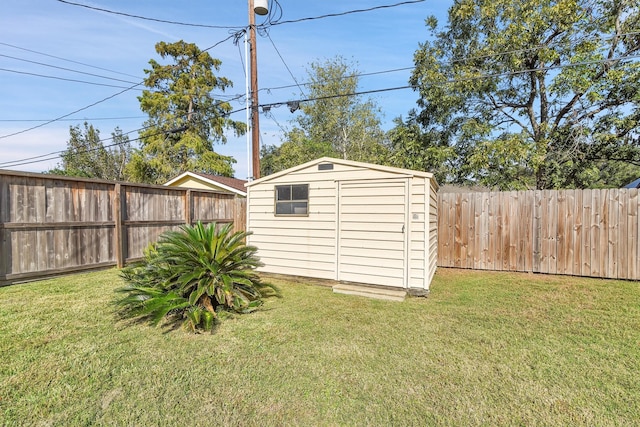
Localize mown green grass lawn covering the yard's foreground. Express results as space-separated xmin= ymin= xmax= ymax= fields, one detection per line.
xmin=0 ymin=269 xmax=640 ymax=426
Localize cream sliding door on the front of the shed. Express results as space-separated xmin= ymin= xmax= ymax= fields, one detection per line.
xmin=337 ymin=179 xmax=408 ymax=287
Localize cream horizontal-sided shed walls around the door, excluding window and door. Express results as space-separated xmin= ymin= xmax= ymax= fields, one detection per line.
xmin=247 ymin=159 xmax=437 ymax=289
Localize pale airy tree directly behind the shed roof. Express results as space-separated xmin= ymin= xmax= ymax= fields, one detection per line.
xmin=261 ymin=57 xmax=388 ymax=175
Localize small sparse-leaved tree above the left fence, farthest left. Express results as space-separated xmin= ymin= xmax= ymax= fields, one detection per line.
xmin=48 ymin=122 xmax=131 ymax=181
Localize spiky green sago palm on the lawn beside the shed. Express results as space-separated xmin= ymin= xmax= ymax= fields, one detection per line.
xmin=117 ymin=222 xmax=276 ymax=332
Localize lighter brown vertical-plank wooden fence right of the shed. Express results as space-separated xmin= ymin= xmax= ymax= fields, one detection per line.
xmin=438 ymin=189 xmax=640 ymax=280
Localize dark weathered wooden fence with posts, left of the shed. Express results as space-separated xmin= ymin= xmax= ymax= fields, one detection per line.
xmin=0 ymin=170 xmax=246 ymax=284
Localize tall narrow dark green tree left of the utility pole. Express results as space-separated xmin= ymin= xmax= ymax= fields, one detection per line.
xmin=130 ymin=41 xmax=246 ymax=183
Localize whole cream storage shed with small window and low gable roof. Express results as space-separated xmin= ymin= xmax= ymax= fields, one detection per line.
xmin=246 ymin=157 xmax=438 ymax=292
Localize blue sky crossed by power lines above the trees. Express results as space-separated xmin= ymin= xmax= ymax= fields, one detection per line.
xmin=0 ymin=0 xmax=452 ymax=179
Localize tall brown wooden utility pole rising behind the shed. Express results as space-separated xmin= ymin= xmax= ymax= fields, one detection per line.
xmin=249 ymin=0 xmax=267 ymax=179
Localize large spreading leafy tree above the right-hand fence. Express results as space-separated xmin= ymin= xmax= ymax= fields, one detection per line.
xmin=410 ymin=0 xmax=640 ymax=189
